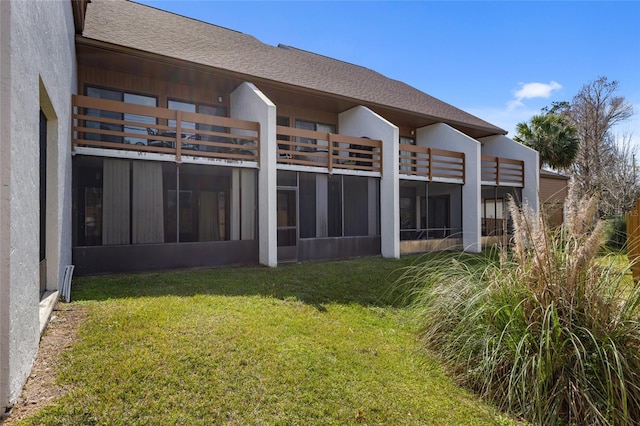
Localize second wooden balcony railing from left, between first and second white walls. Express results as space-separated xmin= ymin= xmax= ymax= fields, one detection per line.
xmin=277 ymin=126 xmax=382 ymax=174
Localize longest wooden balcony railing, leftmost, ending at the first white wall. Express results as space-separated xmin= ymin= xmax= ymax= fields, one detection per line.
xmin=72 ymin=95 xmax=260 ymax=162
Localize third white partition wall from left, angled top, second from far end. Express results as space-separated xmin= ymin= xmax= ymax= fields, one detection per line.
xmin=416 ymin=123 xmax=482 ymax=253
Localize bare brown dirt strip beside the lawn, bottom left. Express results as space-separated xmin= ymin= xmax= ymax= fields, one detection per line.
xmin=0 ymin=303 xmax=87 ymax=426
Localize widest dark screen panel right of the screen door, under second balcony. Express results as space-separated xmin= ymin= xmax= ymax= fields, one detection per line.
xmin=343 ymin=176 xmax=369 ymax=237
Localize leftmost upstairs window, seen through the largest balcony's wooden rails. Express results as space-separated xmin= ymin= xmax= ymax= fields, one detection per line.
xmin=86 ymin=86 xmax=157 ymax=145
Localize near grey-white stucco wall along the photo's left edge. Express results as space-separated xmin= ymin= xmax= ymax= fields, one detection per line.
xmin=0 ymin=1 xmax=76 ymax=411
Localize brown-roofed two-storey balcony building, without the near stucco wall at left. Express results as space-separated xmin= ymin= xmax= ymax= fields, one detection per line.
xmin=72 ymin=1 xmax=538 ymax=275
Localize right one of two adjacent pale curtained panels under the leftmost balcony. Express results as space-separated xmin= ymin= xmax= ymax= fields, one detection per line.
xmin=131 ymin=161 xmax=164 ymax=244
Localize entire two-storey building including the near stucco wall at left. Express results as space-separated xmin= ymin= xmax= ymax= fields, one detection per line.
xmin=0 ymin=0 xmax=538 ymax=412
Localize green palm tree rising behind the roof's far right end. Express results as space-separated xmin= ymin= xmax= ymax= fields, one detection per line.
xmin=513 ymin=112 xmax=580 ymax=169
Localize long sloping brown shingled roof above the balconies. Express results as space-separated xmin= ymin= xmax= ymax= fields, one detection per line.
xmin=82 ymin=0 xmax=507 ymax=134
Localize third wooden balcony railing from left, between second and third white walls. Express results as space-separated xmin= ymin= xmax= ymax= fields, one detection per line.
xmin=399 ymin=144 xmax=465 ymax=183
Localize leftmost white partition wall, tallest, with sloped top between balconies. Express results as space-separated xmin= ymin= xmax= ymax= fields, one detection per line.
xmin=230 ymin=82 xmax=278 ymax=267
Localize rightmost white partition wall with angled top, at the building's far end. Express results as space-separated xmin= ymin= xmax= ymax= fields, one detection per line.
xmin=479 ymin=135 xmax=540 ymax=212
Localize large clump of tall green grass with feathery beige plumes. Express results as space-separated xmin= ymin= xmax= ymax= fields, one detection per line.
xmin=410 ymin=194 xmax=640 ymax=425
